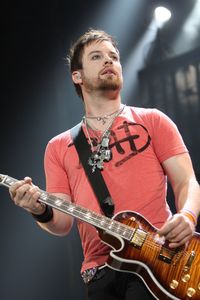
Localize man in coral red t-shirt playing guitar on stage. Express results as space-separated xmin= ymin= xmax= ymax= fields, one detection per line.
xmin=10 ymin=30 xmax=200 ymax=300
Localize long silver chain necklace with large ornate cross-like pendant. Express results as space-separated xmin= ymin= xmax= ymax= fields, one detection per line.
xmin=83 ymin=105 xmax=125 ymax=173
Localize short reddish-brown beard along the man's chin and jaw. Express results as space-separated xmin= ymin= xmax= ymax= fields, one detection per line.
xmin=82 ymin=75 xmax=122 ymax=92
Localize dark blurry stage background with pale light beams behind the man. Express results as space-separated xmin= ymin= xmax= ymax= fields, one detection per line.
xmin=0 ymin=0 xmax=200 ymax=300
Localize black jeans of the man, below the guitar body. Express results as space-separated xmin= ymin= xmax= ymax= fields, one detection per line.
xmin=86 ymin=267 xmax=155 ymax=300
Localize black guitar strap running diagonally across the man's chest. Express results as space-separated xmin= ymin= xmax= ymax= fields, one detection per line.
xmin=70 ymin=123 xmax=114 ymax=218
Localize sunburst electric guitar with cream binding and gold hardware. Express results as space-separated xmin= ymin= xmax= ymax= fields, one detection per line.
xmin=0 ymin=175 xmax=200 ymax=300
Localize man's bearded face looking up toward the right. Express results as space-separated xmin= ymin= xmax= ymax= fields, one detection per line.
xmin=81 ymin=41 xmax=123 ymax=91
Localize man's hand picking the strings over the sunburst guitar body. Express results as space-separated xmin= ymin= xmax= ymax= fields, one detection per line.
xmin=158 ymin=214 xmax=195 ymax=248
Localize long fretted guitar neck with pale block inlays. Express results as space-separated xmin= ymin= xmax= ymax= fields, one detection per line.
xmin=0 ymin=174 xmax=134 ymax=241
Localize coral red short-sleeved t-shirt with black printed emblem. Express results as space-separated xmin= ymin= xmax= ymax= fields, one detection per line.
xmin=45 ymin=107 xmax=187 ymax=271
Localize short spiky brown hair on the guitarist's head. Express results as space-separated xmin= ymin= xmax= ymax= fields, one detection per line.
xmin=67 ymin=28 xmax=119 ymax=98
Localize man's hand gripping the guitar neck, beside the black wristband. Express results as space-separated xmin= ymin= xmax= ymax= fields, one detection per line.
xmin=9 ymin=177 xmax=45 ymax=215
